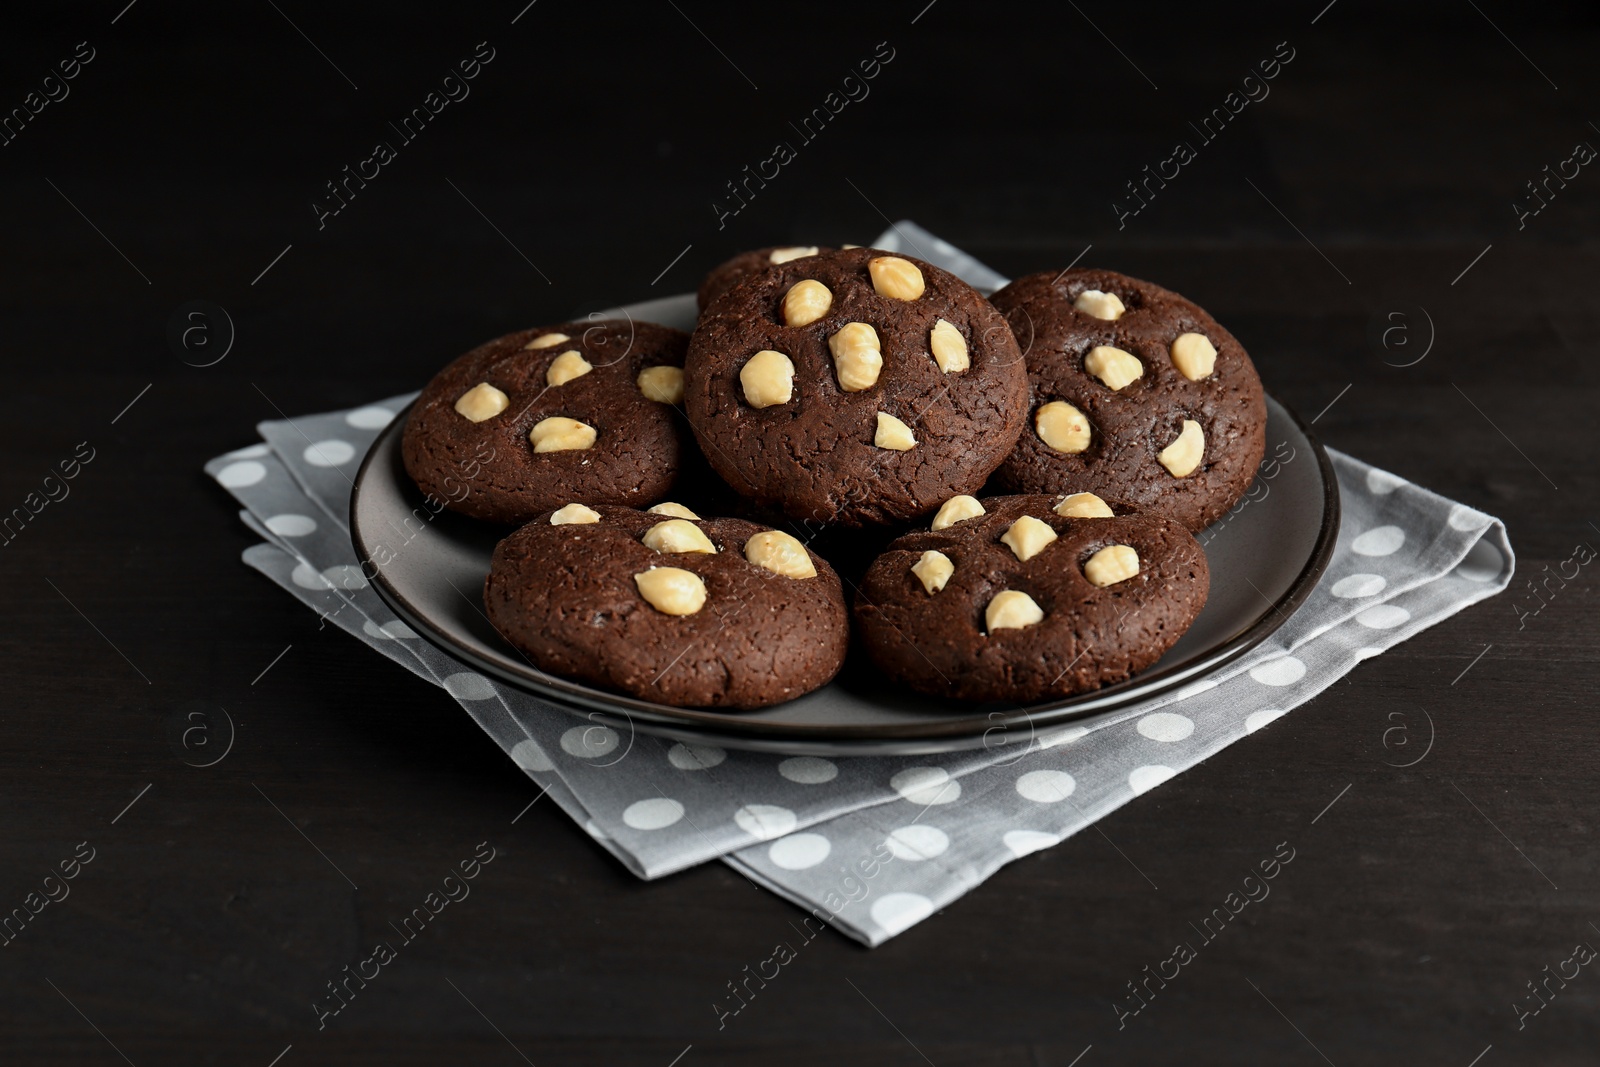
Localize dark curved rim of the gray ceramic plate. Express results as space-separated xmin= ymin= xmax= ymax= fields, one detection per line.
xmin=349 ymin=394 xmax=1341 ymax=752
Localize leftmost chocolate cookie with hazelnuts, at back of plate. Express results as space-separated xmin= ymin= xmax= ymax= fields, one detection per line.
xmin=402 ymin=320 xmax=693 ymax=522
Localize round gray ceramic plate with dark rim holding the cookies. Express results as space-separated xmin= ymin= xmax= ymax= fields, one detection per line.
xmin=350 ymin=294 xmax=1339 ymax=755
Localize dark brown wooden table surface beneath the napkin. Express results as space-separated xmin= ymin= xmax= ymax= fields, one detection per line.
xmin=0 ymin=0 xmax=1600 ymax=1067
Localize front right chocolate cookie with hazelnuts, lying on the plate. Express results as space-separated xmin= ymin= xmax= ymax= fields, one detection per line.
xmin=854 ymin=493 xmax=1210 ymax=704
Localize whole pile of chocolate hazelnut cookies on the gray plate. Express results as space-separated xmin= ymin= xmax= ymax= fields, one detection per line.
xmin=403 ymin=246 xmax=1266 ymax=709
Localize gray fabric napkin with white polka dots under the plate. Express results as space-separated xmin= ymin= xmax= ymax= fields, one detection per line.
xmin=206 ymin=222 xmax=1514 ymax=940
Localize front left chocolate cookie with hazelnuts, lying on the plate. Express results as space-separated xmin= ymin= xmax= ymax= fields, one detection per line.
xmin=483 ymin=504 xmax=850 ymax=707
